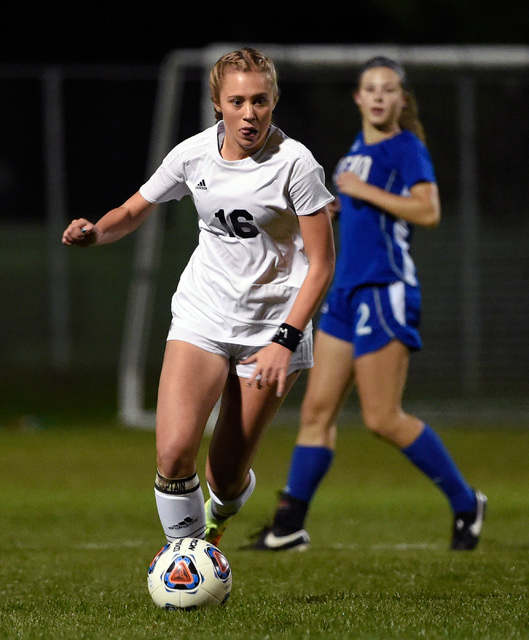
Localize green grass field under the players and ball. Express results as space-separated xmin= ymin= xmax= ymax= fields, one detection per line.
xmin=0 ymin=423 xmax=529 ymax=640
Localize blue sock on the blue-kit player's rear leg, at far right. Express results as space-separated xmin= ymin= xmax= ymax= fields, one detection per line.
xmin=401 ymin=424 xmax=476 ymax=513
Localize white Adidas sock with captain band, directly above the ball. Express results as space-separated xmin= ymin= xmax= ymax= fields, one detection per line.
xmin=154 ymin=472 xmax=206 ymax=542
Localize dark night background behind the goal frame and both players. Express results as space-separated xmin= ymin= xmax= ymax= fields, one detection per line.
xmin=0 ymin=0 xmax=529 ymax=417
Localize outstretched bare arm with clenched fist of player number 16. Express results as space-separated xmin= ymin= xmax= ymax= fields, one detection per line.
xmin=62 ymin=191 xmax=156 ymax=247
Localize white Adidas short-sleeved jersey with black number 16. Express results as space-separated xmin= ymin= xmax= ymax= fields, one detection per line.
xmin=140 ymin=122 xmax=333 ymax=344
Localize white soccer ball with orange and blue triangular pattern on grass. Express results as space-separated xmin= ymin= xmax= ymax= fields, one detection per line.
xmin=147 ymin=538 xmax=232 ymax=609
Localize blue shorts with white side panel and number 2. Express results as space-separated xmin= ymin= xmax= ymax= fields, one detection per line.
xmin=318 ymin=282 xmax=422 ymax=357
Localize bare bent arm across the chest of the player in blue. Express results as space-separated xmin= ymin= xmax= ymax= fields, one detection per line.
xmin=336 ymin=171 xmax=441 ymax=227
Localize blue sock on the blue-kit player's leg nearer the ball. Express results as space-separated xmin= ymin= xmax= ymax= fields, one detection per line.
xmin=285 ymin=445 xmax=334 ymax=503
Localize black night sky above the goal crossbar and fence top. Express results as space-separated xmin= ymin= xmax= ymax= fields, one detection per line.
xmin=0 ymin=0 xmax=529 ymax=64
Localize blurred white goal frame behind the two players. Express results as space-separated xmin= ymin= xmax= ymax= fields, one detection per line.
xmin=118 ymin=43 xmax=529 ymax=428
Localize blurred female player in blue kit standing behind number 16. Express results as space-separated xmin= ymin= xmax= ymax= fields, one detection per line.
xmin=251 ymin=56 xmax=487 ymax=550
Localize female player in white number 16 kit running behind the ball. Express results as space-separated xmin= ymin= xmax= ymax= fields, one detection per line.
xmin=63 ymin=48 xmax=335 ymax=544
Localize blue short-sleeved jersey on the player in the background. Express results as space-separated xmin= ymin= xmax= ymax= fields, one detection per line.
xmin=333 ymin=131 xmax=436 ymax=289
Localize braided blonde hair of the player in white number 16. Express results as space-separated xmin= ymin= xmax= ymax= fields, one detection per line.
xmin=209 ymin=47 xmax=279 ymax=120
